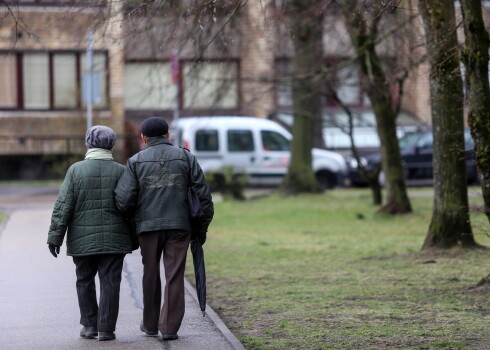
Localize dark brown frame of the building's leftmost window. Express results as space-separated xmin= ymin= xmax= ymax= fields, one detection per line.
xmin=0 ymin=50 xmax=111 ymax=112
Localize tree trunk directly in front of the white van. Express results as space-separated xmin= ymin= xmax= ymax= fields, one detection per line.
xmin=282 ymin=0 xmax=323 ymax=194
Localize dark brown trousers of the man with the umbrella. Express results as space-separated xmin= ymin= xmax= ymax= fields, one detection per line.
xmin=138 ymin=230 xmax=191 ymax=334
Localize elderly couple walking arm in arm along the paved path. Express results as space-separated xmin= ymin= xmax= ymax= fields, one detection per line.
xmin=48 ymin=117 xmax=214 ymax=340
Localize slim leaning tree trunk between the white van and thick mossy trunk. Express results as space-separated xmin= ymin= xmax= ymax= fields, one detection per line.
xmin=342 ymin=0 xmax=412 ymax=214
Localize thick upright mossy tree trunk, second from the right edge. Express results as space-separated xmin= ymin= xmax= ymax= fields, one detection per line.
xmin=419 ymin=0 xmax=476 ymax=249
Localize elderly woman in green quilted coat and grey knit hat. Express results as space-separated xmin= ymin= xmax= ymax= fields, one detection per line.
xmin=48 ymin=125 xmax=133 ymax=340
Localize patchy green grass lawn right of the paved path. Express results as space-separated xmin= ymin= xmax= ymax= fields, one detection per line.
xmin=197 ymin=189 xmax=490 ymax=350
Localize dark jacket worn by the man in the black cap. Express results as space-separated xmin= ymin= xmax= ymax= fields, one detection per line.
xmin=115 ymin=137 xmax=214 ymax=236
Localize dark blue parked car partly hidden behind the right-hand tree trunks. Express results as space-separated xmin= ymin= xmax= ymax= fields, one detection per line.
xmin=346 ymin=129 xmax=478 ymax=185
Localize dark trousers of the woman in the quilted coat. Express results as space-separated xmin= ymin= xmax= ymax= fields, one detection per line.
xmin=73 ymin=254 xmax=124 ymax=332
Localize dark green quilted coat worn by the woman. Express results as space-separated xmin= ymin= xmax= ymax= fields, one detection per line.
xmin=48 ymin=159 xmax=132 ymax=256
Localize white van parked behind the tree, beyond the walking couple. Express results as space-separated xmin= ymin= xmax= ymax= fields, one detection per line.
xmin=170 ymin=117 xmax=347 ymax=188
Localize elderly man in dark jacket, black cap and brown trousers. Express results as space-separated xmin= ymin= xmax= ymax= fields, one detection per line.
xmin=115 ymin=117 xmax=214 ymax=340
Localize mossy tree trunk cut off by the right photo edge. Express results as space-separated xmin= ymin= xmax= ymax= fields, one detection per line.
xmin=460 ymin=0 xmax=490 ymax=221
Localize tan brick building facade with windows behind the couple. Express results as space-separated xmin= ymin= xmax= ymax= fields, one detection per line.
xmin=0 ymin=0 xmax=480 ymax=179
